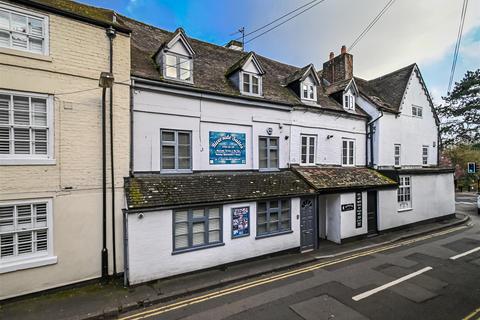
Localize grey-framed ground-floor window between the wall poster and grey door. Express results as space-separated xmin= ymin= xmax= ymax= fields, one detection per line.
xmin=257 ymin=199 xmax=291 ymax=236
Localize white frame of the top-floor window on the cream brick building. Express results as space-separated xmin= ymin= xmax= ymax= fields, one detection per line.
xmin=0 ymin=2 xmax=50 ymax=56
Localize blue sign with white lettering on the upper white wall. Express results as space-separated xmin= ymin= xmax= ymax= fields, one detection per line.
xmin=209 ymin=131 xmax=246 ymax=164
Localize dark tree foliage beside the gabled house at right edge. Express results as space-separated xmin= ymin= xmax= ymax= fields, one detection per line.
xmin=437 ymin=69 xmax=480 ymax=146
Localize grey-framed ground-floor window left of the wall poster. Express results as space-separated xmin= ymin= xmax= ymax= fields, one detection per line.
xmin=173 ymin=207 xmax=223 ymax=251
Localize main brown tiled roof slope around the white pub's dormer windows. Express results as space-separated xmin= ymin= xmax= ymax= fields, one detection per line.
xmin=121 ymin=16 xmax=365 ymax=116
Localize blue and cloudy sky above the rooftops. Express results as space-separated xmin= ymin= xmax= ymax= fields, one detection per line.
xmin=77 ymin=0 xmax=480 ymax=103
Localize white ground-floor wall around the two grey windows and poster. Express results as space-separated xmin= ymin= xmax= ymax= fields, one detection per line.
xmin=128 ymin=198 xmax=300 ymax=284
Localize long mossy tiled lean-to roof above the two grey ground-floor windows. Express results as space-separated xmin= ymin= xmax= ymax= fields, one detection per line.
xmin=125 ymin=170 xmax=315 ymax=210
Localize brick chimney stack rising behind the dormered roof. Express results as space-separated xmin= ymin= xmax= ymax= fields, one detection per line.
xmin=322 ymin=46 xmax=353 ymax=83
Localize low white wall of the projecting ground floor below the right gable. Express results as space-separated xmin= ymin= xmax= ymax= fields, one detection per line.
xmin=378 ymin=173 xmax=455 ymax=230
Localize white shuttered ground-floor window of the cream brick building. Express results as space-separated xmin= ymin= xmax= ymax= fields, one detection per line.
xmin=0 ymin=200 xmax=51 ymax=264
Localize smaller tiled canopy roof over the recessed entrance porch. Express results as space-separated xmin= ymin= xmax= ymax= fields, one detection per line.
xmin=294 ymin=166 xmax=397 ymax=192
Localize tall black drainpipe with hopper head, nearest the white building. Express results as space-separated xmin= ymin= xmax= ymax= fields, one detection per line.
xmin=107 ymin=26 xmax=117 ymax=275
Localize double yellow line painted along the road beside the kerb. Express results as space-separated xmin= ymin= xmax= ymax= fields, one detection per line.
xmin=120 ymin=225 xmax=467 ymax=320
